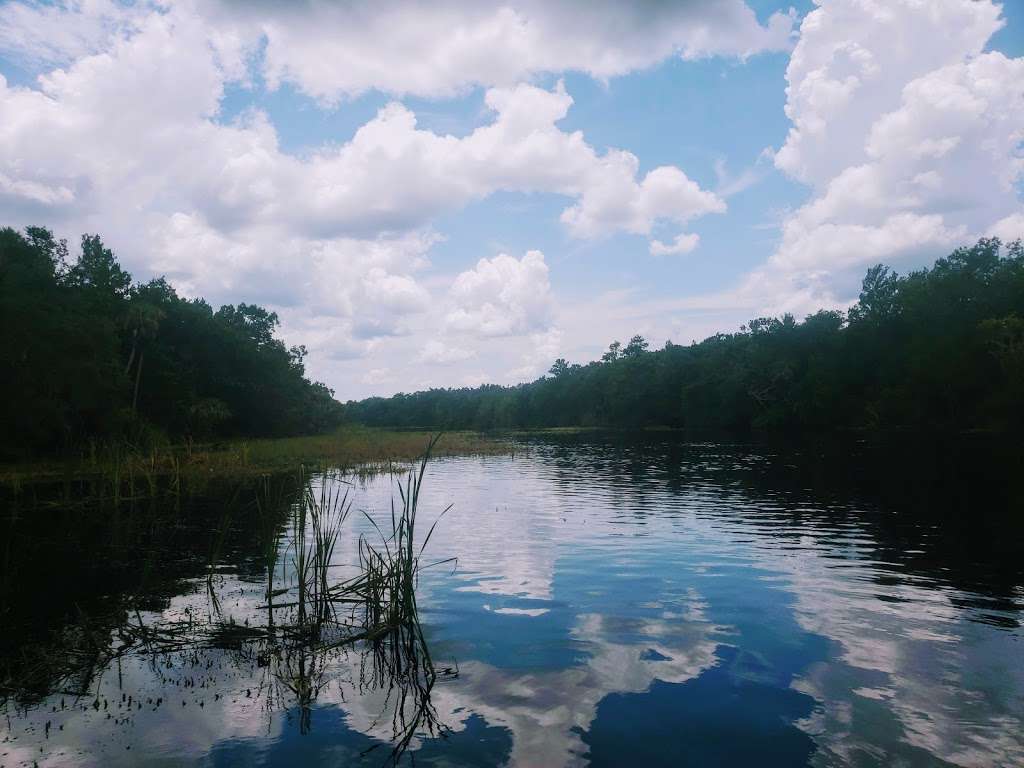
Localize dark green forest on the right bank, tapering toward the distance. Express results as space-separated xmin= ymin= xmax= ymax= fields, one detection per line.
xmin=345 ymin=239 xmax=1024 ymax=432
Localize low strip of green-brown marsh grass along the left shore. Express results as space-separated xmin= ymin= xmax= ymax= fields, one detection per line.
xmin=0 ymin=426 xmax=512 ymax=487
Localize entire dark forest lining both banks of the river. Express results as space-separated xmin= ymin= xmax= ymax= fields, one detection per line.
xmin=8 ymin=227 xmax=1024 ymax=460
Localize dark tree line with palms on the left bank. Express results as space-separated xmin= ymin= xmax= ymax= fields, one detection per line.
xmin=0 ymin=227 xmax=342 ymax=458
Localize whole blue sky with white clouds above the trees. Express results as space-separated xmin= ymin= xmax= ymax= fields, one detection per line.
xmin=0 ymin=0 xmax=1024 ymax=400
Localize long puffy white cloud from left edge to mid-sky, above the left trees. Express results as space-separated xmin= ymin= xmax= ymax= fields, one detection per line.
xmin=0 ymin=24 xmax=724 ymax=268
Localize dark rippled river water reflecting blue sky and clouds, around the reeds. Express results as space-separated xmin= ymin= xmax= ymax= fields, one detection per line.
xmin=0 ymin=435 xmax=1024 ymax=766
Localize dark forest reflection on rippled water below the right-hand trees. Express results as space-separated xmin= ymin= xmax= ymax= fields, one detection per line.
xmin=527 ymin=432 xmax=1024 ymax=627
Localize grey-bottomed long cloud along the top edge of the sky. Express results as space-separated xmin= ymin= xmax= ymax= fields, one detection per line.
xmin=199 ymin=0 xmax=794 ymax=101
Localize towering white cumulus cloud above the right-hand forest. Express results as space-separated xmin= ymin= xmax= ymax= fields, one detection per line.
xmin=723 ymin=0 xmax=1024 ymax=311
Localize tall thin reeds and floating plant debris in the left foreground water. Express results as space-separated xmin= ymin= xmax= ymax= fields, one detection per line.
xmin=0 ymin=437 xmax=458 ymax=763
